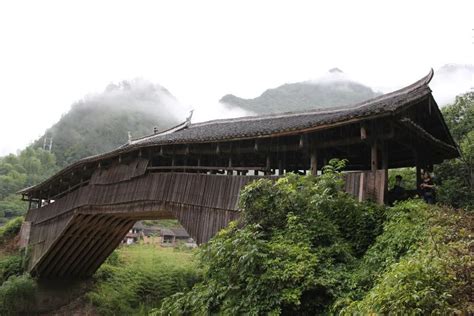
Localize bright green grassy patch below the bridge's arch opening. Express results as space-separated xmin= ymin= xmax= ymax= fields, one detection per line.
xmin=86 ymin=244 xmax=201 ymax=315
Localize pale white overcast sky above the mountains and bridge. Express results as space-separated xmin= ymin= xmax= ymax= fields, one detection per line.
xmin=0 ymin=0 xmax=474 ymax=155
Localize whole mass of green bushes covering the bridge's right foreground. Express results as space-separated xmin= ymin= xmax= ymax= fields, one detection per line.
xmin=155 ymin=168 xmax=472 ymax=315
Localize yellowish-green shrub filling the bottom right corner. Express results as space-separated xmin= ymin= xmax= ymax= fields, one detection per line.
xmin=333 ymin=201 xmax=473 ymax=315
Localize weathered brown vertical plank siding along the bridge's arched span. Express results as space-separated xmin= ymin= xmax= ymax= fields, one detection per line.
xmin=26 ymin=170 xmax=270 ymax=276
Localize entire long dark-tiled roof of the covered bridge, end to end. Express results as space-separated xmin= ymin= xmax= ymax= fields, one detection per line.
xmin=19 ymin=69 xmax=459 ymax=195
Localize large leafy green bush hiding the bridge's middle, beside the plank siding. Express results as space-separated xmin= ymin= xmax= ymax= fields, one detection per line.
xmin=156 ymin=166 xmax=383 ymax=315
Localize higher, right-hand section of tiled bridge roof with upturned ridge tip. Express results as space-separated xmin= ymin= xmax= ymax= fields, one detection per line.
xmin=129 ymin=70 xmax=433 ymax=146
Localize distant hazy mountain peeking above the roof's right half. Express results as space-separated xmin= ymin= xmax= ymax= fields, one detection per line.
xmin=220 ymin=68 xmax=380 ymax=114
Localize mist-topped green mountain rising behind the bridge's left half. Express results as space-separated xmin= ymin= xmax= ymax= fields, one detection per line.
xmin=34 ymin=79 xmax=183 ymax=166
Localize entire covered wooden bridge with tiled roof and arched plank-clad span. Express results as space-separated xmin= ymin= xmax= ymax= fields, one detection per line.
xmin=20 ymin=71 xmax=459 ymax=277
